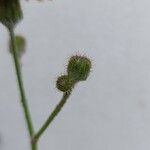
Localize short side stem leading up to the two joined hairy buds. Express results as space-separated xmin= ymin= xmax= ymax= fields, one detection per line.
xmin=32 ymin=91 xmax=71 ymax=143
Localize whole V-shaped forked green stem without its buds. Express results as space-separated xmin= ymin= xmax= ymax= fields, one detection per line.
xmin=8 ymin=27 xmax=71 ymax=150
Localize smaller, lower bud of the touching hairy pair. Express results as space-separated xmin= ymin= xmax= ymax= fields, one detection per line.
xmin=56 ymin=75 xmax=74 ymax=92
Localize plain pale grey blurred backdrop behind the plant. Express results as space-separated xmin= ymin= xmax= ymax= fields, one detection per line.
xmin=0 ymin=0 xmax=150 ymax=150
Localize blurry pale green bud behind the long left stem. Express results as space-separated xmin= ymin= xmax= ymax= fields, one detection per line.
xmin=9 ymin=35 xmax=26 ymax=58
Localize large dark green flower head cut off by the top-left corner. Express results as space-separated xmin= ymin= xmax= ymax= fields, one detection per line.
xmin=0 ymin=0 xmax=23 ymax=27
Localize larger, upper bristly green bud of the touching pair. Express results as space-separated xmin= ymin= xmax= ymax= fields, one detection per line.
xmin=67 ymin=55 xmax=91 ymax=81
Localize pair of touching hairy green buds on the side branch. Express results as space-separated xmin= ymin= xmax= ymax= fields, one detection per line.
xmin=56 ymin=55 xmax=91 ymax=92
